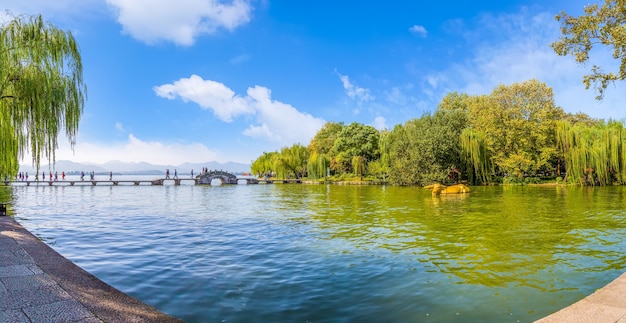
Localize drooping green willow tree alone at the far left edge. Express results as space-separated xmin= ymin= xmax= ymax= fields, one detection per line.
xmin=0 ymin=16 xmax=87 ymax=175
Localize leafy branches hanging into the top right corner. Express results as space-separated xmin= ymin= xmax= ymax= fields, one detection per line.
xmin=550 ymin=0 xmax=626 ymax=99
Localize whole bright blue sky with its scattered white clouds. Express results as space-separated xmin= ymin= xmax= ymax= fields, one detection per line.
xmin=0 ymin=0 xmax=626 ymax=165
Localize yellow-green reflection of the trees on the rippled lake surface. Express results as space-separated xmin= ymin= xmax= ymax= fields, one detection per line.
xmin=278 ymin=186 xmax=626 ymax=291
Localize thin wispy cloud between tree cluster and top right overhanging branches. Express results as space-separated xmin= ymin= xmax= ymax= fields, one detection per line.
xmin=423 ymin=10 xmax=626 ymax=119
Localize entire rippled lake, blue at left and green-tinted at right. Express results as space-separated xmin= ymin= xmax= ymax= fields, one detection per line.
xmin=0 ymin=180 xmax=626 ymax=322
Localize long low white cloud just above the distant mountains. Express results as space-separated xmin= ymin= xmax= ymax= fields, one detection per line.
xmin=22 ymin=134 xmax=222 ymax=167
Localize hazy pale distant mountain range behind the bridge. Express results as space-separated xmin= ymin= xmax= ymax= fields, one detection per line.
xmin=20 ymin=160 xmax=250 ymax=175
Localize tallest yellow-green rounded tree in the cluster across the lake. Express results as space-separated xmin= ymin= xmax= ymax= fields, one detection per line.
xmin=461 ymin=80 xmax=564 ymax=183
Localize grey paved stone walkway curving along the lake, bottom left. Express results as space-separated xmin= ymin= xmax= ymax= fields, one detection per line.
xmin=0 ymin=216 xmax=182 ymax=323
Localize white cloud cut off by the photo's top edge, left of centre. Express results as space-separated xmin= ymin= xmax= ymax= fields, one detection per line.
xmin=106 ymin=0 xmax=252 ymax=46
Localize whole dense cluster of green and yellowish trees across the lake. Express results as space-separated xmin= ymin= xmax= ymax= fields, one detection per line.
xmin=252 ymin=80 xmax=626 ymax=185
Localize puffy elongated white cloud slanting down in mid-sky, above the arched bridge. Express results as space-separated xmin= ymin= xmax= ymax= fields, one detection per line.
xmin=154 ymin=75 xmax=325 ymax=145
